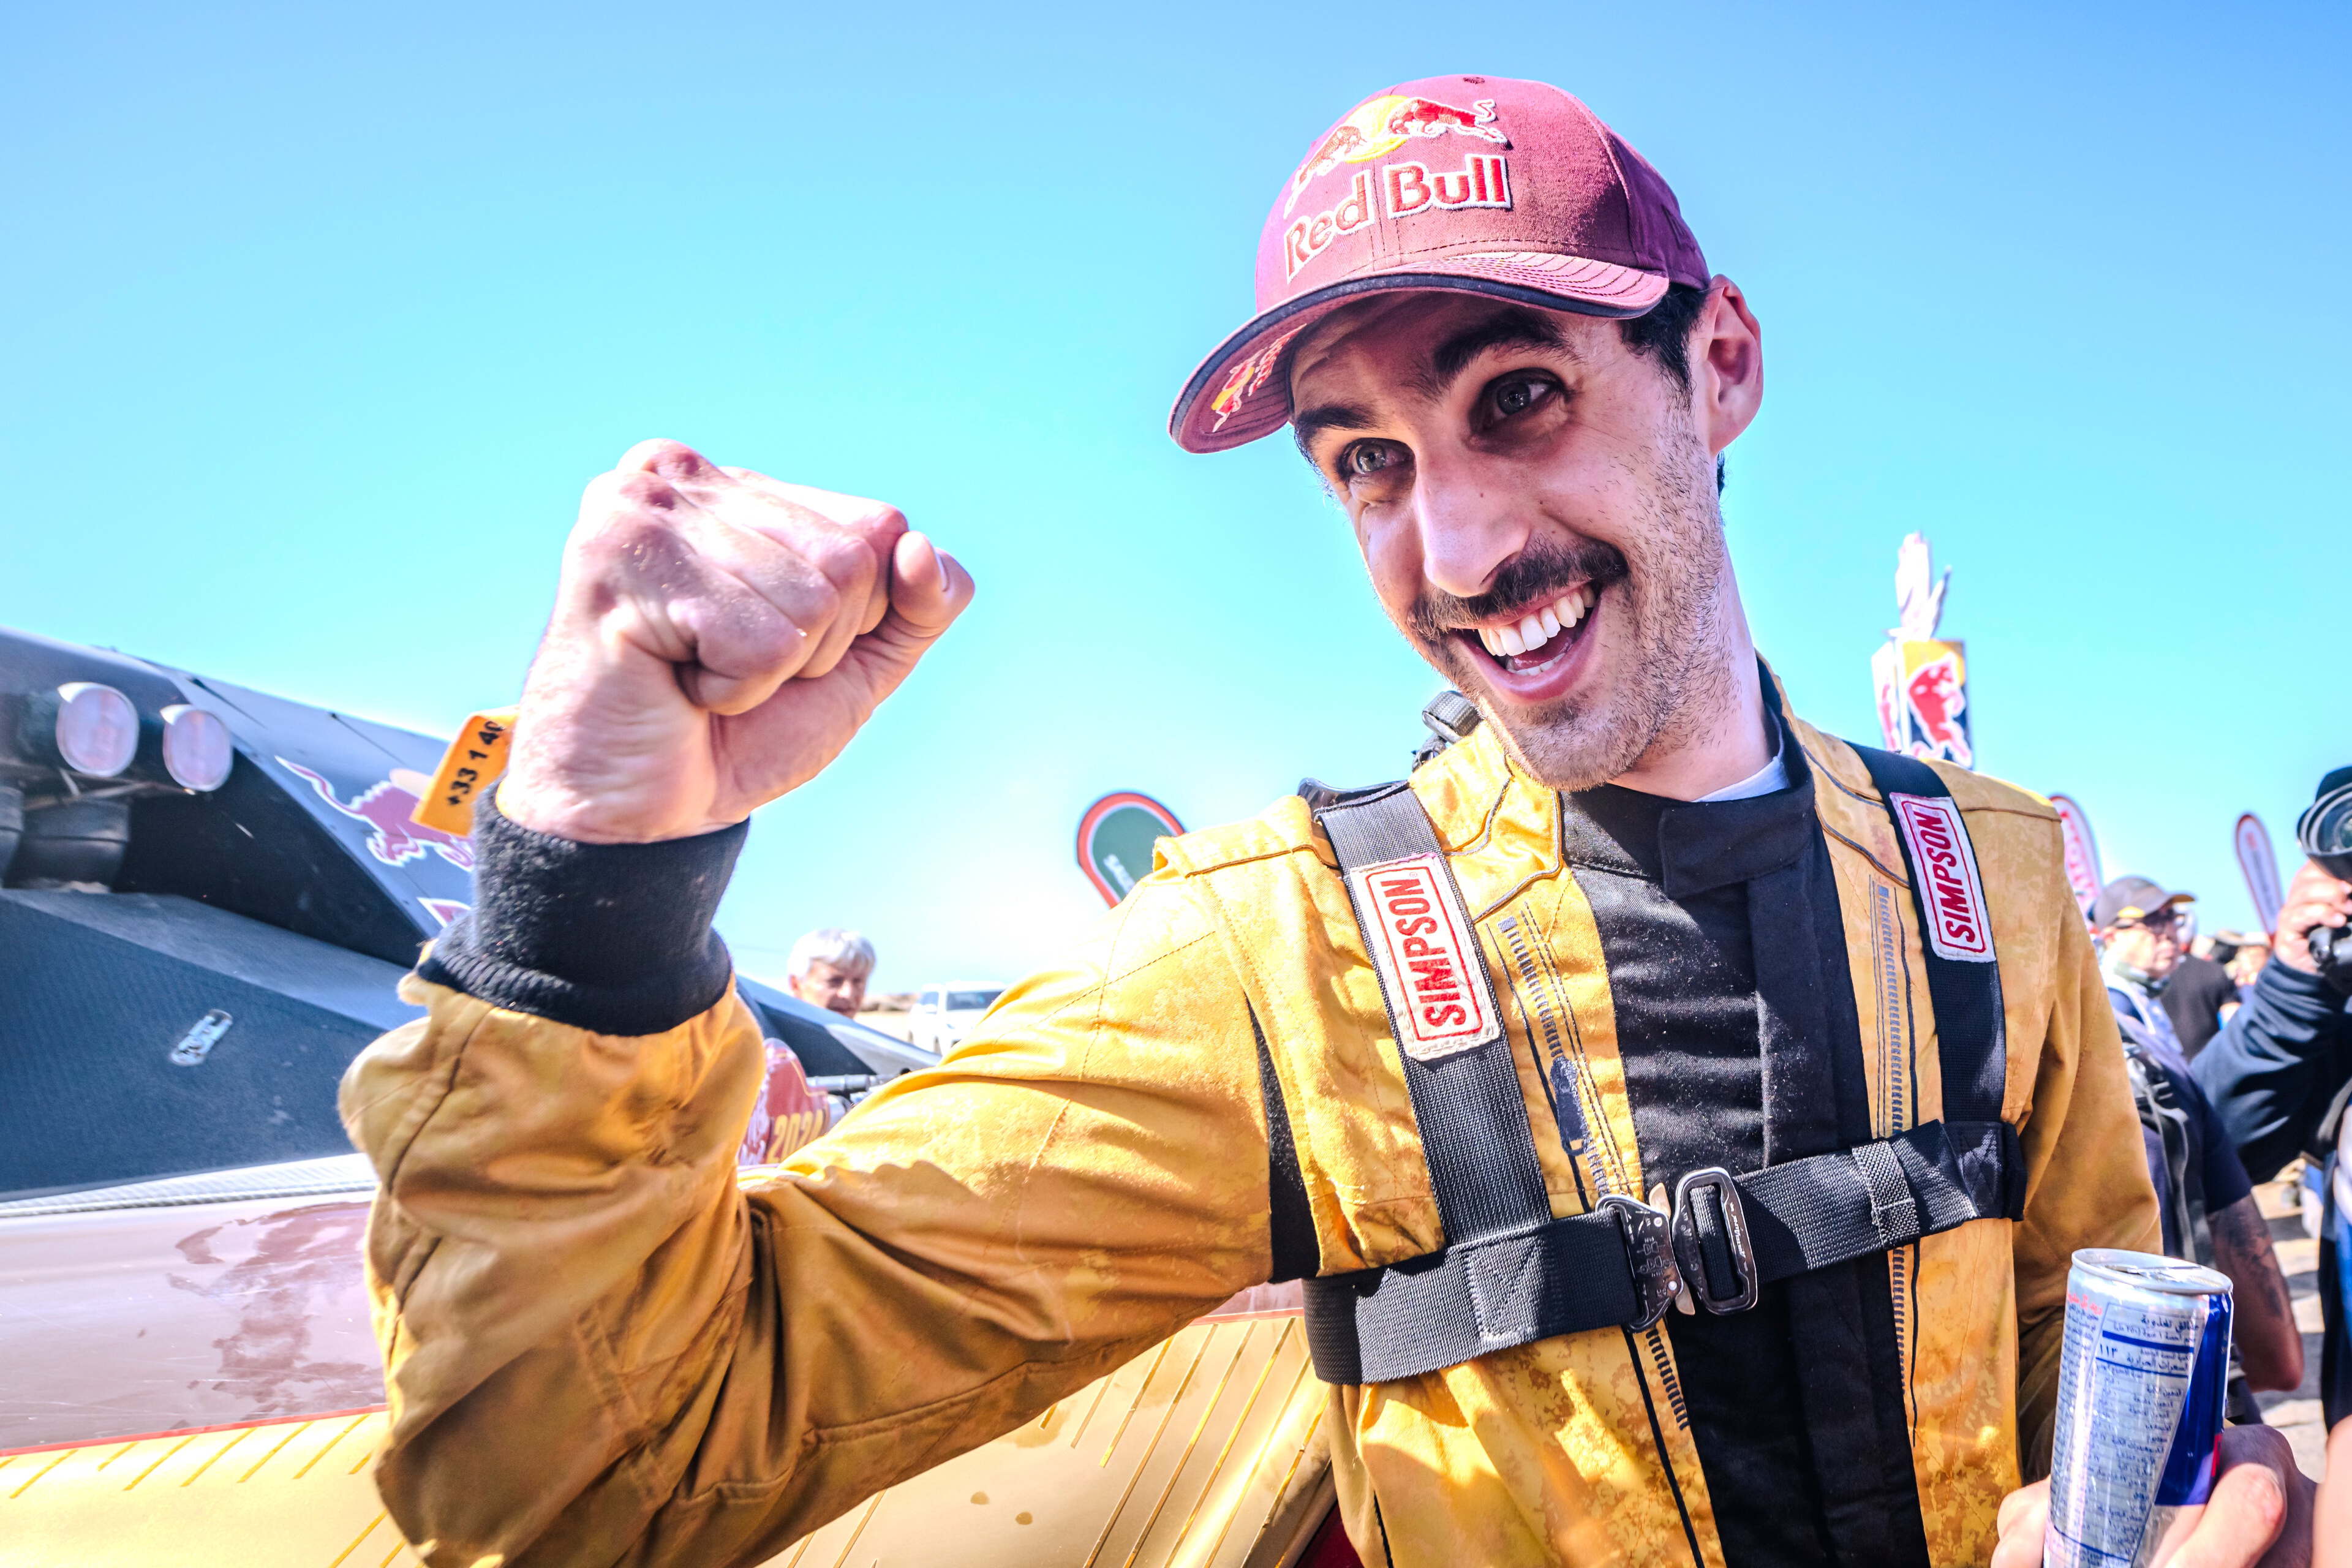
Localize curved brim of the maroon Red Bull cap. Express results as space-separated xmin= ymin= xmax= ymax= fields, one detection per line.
xmin=1169 ymin=252 xmax=1668 ymax=451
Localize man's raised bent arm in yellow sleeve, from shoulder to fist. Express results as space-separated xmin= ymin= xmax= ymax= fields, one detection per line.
xmin=344 ymin=449 xmax=1268 ymax=1566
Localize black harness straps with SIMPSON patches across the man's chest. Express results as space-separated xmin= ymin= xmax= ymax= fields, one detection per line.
xmin=1305 ymin=748 xmax=2022 ymax=1385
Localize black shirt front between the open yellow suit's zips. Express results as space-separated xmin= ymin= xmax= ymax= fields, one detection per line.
xmin=1562 ymin=719 xmax=1926 ymax=1568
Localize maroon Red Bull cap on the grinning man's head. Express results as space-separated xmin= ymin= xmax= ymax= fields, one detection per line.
xmin=1169 ymin=75 xmax=1708 ymax=451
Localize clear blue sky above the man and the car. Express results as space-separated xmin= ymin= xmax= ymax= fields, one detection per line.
xmin=0 ymin=2 xmax=2352 ymax=987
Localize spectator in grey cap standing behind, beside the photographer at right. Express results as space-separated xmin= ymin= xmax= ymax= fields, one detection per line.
xmin=2091 ymin=877 xmax=2302 ymax=1422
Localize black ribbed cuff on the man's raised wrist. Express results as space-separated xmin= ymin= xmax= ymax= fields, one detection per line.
xmin=417 ymin=792 xmax=750 ymax=1035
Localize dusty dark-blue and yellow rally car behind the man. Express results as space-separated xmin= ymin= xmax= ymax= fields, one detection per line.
xmin=0 ymin=630 xmax=1355 ymax=1568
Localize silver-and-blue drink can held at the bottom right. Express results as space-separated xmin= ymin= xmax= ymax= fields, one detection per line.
xmin=2044 ymin=1248 xmax=2230 ymax=1568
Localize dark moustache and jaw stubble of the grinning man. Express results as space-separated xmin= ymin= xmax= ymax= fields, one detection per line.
xmin=1404 ymin=421 xmax=1733 ymax=790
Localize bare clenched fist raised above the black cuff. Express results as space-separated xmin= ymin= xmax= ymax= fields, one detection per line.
xmin=499 ymin=442 xmax=971 ymax=844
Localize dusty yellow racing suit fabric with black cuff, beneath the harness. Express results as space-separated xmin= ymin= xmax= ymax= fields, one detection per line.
xmin=344 ymin=691 xmax=2157 ymax=1566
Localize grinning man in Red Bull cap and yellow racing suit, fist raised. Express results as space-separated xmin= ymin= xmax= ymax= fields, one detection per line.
xmin=322 ymin=75 xmax=2305 ymax=1568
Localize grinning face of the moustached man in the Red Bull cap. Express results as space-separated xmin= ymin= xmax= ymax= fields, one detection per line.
xmin=1291 ymin=284 xmax=1752 ymax=790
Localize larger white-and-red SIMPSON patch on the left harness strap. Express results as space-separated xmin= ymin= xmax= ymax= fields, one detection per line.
xmin=1350 ymin=856 xmax=1503 ymax=1063
